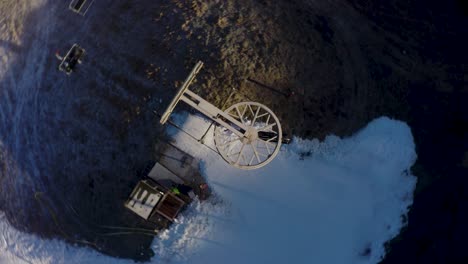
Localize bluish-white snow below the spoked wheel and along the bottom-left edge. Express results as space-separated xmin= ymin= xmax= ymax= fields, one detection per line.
xmin=0 ymin=113 xmax=416 ymax=264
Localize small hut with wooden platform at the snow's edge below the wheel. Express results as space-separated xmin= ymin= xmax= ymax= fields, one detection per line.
xmin=125 ymin=144 xmax=210 ymax=224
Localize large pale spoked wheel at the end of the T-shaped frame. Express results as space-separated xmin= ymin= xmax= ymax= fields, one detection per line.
xmin=214 ymin=102 xmax=282 ymax=170
